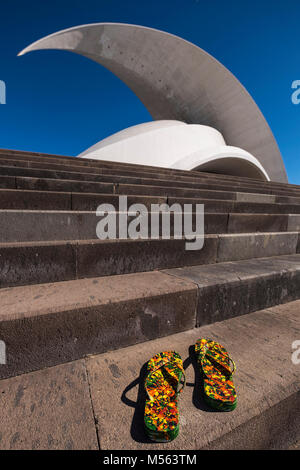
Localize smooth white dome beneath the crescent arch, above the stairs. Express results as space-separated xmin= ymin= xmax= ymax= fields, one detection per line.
xmin=79 ymin=120 xmax=270 ymax=180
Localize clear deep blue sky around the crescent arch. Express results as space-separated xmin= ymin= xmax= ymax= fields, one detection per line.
xmin=0 ymin=0 xmax=300 ymax=184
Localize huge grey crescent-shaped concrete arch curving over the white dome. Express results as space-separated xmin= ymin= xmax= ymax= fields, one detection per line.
xmin=19 ymin=23 xmax=287 ymax=182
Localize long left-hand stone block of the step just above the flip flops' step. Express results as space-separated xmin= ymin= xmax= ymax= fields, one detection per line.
xmin=0 ymin=272 xmax=197 ymax=378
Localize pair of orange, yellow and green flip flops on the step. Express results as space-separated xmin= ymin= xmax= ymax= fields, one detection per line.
xmin=144 ymin=339 xmax=237 ymax=442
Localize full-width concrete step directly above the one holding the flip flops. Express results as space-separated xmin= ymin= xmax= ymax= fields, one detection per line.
xmin=0 ymin=255 xmax=300 ymax=378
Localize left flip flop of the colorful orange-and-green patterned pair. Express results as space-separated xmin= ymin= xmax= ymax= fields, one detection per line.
xmin=144 ymin=351 xmax=185 ymax=442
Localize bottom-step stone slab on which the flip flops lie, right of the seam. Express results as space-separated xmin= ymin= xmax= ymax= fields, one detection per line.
xmin=87 ymin=302 xmax=300 ymax=450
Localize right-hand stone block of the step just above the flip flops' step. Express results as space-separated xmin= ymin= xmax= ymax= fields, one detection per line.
xmin=163 ymin=255 xmax=300 ymax=326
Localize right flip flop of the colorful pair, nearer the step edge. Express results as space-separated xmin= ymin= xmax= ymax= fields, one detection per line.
xmin=195 ymin=339 xmax=237 ymax=411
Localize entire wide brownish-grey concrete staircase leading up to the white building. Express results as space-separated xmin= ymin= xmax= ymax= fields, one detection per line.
xmin=0 ymin=150 xmax=300 ymax=449
